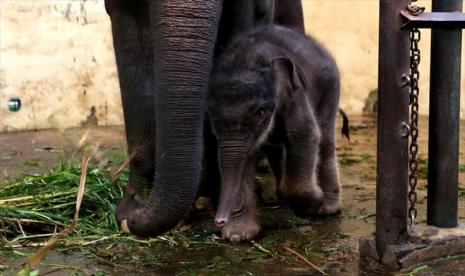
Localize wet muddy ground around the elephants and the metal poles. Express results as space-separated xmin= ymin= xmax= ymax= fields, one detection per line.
xmin=0 ymin=117 xmax=465 ymax=275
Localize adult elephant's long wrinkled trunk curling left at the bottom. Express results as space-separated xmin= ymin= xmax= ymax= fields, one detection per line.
xmin=127 ymin=0 xmax=221 ymax=236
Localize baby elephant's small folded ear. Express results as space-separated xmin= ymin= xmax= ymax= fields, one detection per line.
xmin=270 ymin=57 xmax=303 ymax=91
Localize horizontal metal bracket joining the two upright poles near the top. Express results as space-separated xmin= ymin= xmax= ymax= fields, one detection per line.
xmin=400 ymin=9 xmax=465 ymax=30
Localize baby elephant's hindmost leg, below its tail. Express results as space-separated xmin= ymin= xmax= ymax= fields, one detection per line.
xmin=318 ymin=133 xmax=341 ymax=216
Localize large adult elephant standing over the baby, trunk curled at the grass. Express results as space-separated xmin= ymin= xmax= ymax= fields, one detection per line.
xmin=105 ymin=0 xmax=303 ymax=236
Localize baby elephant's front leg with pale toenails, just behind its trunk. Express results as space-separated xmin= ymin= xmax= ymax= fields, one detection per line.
xmin=222 ymin=157 xmax=260 ymax=242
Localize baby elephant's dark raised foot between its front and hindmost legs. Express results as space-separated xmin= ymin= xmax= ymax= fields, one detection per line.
xmin=281 ymin=181 xmax=324 ymax=217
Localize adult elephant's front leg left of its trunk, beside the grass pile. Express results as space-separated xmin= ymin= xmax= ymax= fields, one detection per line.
xmin=105 ymin=0 xmax=155 ymax=221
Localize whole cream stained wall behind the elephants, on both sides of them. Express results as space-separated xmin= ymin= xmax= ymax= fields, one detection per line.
xmin=0 ymin=0 xmax=465 ymax=131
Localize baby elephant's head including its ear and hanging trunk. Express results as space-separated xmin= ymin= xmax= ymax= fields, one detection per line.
xmin=207 ymin=55 xmax=301 ymax=227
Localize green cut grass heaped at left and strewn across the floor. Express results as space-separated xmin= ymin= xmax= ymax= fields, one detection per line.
xmin=0 ymin=156 xmax=356 ymax=275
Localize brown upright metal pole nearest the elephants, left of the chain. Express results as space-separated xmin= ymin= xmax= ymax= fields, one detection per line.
xmin=376 ymin=0 xmax=410 ymax=257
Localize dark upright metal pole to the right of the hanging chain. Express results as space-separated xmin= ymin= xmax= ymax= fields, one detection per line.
xmin=427 ymin=0 xmax=462 ymax=227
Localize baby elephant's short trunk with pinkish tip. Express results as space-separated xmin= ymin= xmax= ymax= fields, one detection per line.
xmin=215 ymin=141 xmax=247 ymax=228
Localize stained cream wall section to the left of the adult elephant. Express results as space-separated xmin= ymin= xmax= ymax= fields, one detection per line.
xmin=0 ymin=0 xmax=123 ymax=131
